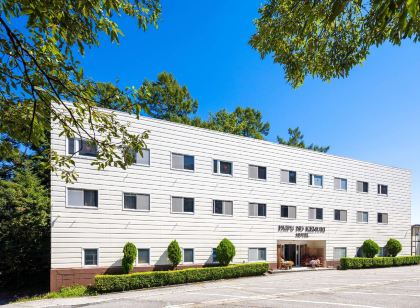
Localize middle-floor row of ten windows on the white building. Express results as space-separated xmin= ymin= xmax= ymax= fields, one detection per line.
xmin=68 ymin=188 xmax=388 ymax=224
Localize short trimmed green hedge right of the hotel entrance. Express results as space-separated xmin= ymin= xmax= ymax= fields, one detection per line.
xmin=340 ymin=256 xmax=420 ymax=270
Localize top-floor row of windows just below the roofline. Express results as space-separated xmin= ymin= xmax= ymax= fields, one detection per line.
xmin=68 ymin=138 xmax=388 ymax=196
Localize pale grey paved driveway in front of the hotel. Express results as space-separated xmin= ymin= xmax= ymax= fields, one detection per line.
xmin=9 ymin=266 xmax=420 ymax=308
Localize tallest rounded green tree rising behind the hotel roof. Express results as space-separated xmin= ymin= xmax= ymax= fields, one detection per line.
xmin=138 ymin=72 xmax=198 ymax=123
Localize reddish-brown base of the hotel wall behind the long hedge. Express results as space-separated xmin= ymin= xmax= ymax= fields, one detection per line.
xmin=50 ymin=263 xmax=277 ymax=291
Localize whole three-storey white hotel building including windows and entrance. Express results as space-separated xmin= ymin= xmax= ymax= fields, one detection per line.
xmin=51 ymin=107 xmax=411 ymax=290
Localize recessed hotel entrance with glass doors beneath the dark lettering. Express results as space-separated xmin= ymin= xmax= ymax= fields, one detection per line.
xmin=277 ymin=240 xmax=326 ymax=268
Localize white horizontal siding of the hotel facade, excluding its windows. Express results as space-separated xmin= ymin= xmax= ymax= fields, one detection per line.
xmin=51 ymin=107 xmax=411 ymax=268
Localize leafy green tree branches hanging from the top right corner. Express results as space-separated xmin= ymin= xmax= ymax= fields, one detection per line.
xmin=249 ymin=0 xmax=420 ymax=87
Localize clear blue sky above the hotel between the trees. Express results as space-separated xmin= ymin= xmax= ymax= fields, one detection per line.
xmin=82 ymin=0 xmax=420 ymax=223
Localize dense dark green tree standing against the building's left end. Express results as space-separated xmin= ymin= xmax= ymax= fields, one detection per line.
xmin=0 ymin=167 xmax=50 ymax=288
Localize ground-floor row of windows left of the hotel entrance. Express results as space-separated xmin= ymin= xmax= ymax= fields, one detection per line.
xmin=83 ymin=248 xmax=267 ymax=266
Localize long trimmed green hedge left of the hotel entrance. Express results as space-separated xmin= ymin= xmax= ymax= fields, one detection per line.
xmin=95 ymin=262 xmax=268 ymax=293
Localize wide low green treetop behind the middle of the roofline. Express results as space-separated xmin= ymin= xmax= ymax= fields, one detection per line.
xmin=203 ymin=107 xmax=270 ymax=139
